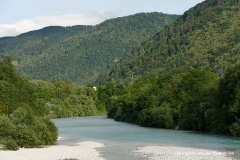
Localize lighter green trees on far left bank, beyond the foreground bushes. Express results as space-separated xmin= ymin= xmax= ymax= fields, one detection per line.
xmin=31 ymin=80 xmax=101 ymax=118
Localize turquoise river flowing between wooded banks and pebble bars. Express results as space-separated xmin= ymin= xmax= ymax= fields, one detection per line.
xmin=53 ymin=116 xmax=240 ymax=160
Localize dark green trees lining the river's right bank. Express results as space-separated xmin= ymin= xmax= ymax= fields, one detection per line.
xmin=98 ymin=65 xmax=240 ymax=137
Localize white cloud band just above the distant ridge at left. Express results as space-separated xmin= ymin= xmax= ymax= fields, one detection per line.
xmin=0 ymin=11 xmax=119 ymax=37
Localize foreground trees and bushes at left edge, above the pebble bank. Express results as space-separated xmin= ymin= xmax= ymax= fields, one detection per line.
xmin=0 ymin=57 xmax=57 ymax=150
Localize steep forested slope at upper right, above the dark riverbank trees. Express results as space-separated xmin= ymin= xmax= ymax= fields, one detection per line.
xmin=97 ymin=0 xmax=240 ymax=85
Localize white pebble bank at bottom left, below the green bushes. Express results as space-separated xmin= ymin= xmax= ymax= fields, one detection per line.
xmin=0 ymin=141 xmax=104 ymax=160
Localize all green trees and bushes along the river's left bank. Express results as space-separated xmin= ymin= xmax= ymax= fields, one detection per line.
xmin=0 ymin=57 xmax=102 ymax=150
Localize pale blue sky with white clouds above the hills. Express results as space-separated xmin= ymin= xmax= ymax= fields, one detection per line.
xmin=0 ymin=0 xmax=204 ymax=37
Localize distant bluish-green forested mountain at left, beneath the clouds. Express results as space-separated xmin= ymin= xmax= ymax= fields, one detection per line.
xmin=0 ymin=13 xmax=179 ymax=84
